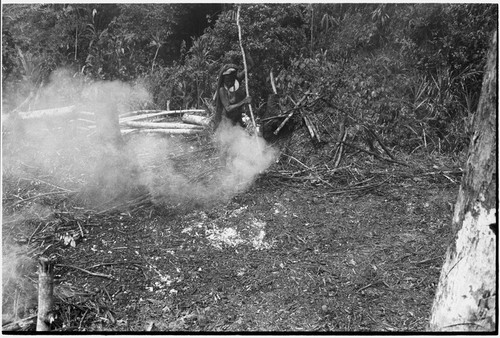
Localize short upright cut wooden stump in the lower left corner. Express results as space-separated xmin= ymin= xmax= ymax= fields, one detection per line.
xmin=36 ymin=257 xmax=54 ymax=331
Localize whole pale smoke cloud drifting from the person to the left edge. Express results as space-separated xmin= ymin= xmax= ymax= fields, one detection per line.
xmin=2 ymin=69 xmax=277 ymax=320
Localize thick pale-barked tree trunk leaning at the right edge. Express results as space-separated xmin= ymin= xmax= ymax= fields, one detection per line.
xmin=429 ymin=33 xmax=498 ymax=331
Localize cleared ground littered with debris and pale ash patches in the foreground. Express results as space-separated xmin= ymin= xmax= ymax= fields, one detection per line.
xmin=41 ymin=170 xmax=458 ymax=332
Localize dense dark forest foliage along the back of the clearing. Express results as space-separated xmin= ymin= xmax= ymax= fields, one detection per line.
xmin=2 ymin=3 xmax=498 ymax=151
